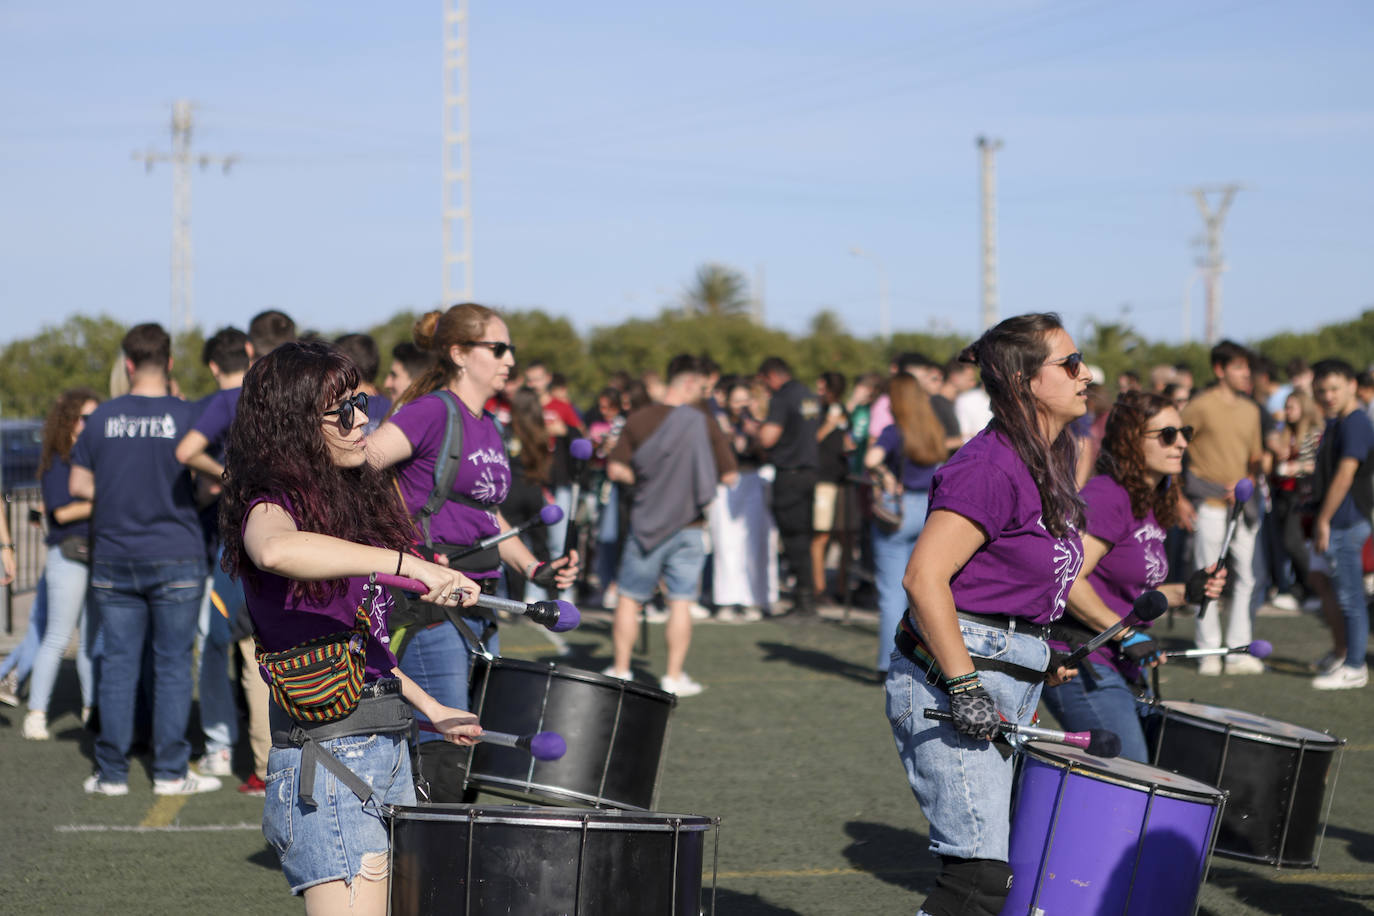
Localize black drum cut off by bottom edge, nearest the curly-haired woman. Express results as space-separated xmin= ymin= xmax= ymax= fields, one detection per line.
xmin=389 ymin=805 xmax=720 ymax=916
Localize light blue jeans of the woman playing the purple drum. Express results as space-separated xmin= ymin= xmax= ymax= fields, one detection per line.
xmin=886 ymin=619 xmax=1050 ymax=862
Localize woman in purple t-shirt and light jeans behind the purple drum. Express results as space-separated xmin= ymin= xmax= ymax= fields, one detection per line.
xmin=886 ymin=314 xmax=1088 ymax=916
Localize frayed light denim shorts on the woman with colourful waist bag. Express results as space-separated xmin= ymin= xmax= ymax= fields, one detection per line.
xmin=262 ymin=732 xmax=415 ymax=894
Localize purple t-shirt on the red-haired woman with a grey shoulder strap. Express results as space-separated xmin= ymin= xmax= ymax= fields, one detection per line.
xmin=392 ymin=391 xmax=511 ymax=568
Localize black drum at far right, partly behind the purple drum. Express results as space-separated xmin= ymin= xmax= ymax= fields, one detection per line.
xmin=1146 ymin=700 xmax=1345 ymax=868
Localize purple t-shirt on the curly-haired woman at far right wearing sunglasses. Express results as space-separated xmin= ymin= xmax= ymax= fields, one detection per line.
xmin=1066 ymin=474 xmax=1169 ymax=674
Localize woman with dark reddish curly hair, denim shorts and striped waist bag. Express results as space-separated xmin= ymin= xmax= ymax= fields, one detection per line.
xmin=220 ymin=342 xmax=481 ymax=913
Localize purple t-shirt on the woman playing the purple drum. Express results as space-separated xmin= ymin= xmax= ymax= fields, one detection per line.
xmin=930 ymin=428 xmax=1083 ymax=623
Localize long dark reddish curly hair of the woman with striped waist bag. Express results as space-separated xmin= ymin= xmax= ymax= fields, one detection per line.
xmin=220 ymin=341 xmax=415 ymax=604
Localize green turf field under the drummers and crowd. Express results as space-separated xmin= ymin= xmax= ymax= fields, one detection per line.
xmin=0 ymin=601 xmax=1374 ymax=916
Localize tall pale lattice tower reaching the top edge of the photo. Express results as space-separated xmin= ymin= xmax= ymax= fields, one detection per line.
xmin=440 ymin=0 xmax=473 ymax=305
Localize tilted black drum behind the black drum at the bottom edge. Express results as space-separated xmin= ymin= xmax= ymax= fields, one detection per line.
xmin=464 ymin=658 xmax=677 ymax=812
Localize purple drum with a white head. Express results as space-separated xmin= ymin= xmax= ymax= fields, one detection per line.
xmin=1002 ymin=742 xmax=1226 ymax=916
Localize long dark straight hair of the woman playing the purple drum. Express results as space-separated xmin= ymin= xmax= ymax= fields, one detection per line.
xmin=959 ymin=312 xmax=1083 ymax=537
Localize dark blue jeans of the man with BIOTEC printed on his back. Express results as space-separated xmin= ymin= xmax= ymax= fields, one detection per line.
xmin=91 ymin=558 xmax=205 ymax=783
